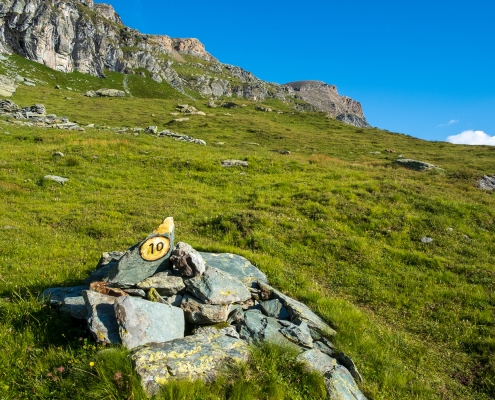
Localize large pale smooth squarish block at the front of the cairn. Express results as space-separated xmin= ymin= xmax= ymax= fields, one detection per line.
xmin=115 ymin=296 xmax=185 ymax=349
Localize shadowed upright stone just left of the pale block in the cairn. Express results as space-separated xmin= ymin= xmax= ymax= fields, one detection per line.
xmin=83 ymin=290 xmax=121 ymax=344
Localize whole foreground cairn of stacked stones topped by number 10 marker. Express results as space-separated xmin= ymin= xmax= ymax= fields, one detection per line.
xmin=41 ymin=217 xmax=365 ymax=399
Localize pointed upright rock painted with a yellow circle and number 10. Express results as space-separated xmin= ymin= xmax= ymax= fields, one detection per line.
xmin=109 ymin=217 xmax=175 ymax=287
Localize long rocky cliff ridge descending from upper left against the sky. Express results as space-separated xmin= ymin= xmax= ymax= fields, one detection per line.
xmin=0 ymin=0 xmax=366 ymax=126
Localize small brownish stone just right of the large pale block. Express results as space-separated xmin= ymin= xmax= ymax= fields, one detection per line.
xmin=180 ymin=293 xmax=230 ymax=324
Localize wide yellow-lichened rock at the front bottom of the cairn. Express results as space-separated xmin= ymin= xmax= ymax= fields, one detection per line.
xmin=132 ymin=334 xmax=248 ymax=396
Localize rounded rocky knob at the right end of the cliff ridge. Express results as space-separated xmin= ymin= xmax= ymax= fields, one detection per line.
xmin=286 ymin=81 xmax=369 ymax=128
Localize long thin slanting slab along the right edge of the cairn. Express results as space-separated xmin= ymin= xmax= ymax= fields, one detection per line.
xmin=258 ymin=281 xmax=337 ymax=335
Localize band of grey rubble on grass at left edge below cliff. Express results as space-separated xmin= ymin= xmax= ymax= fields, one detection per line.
xmin=0 ymin=99 xmax=84 ymax=131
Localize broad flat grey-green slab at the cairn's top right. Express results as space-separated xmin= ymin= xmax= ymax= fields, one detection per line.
xmin=199 ymin=252 xmax=268 ymax=287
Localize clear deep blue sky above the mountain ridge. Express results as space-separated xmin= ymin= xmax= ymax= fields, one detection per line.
xmin=106 ymin=0 xmax=495 ymax=142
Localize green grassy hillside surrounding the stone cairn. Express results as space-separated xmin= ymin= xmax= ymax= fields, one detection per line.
xmin=0 ymin=54 xmax=495 ymax=399
